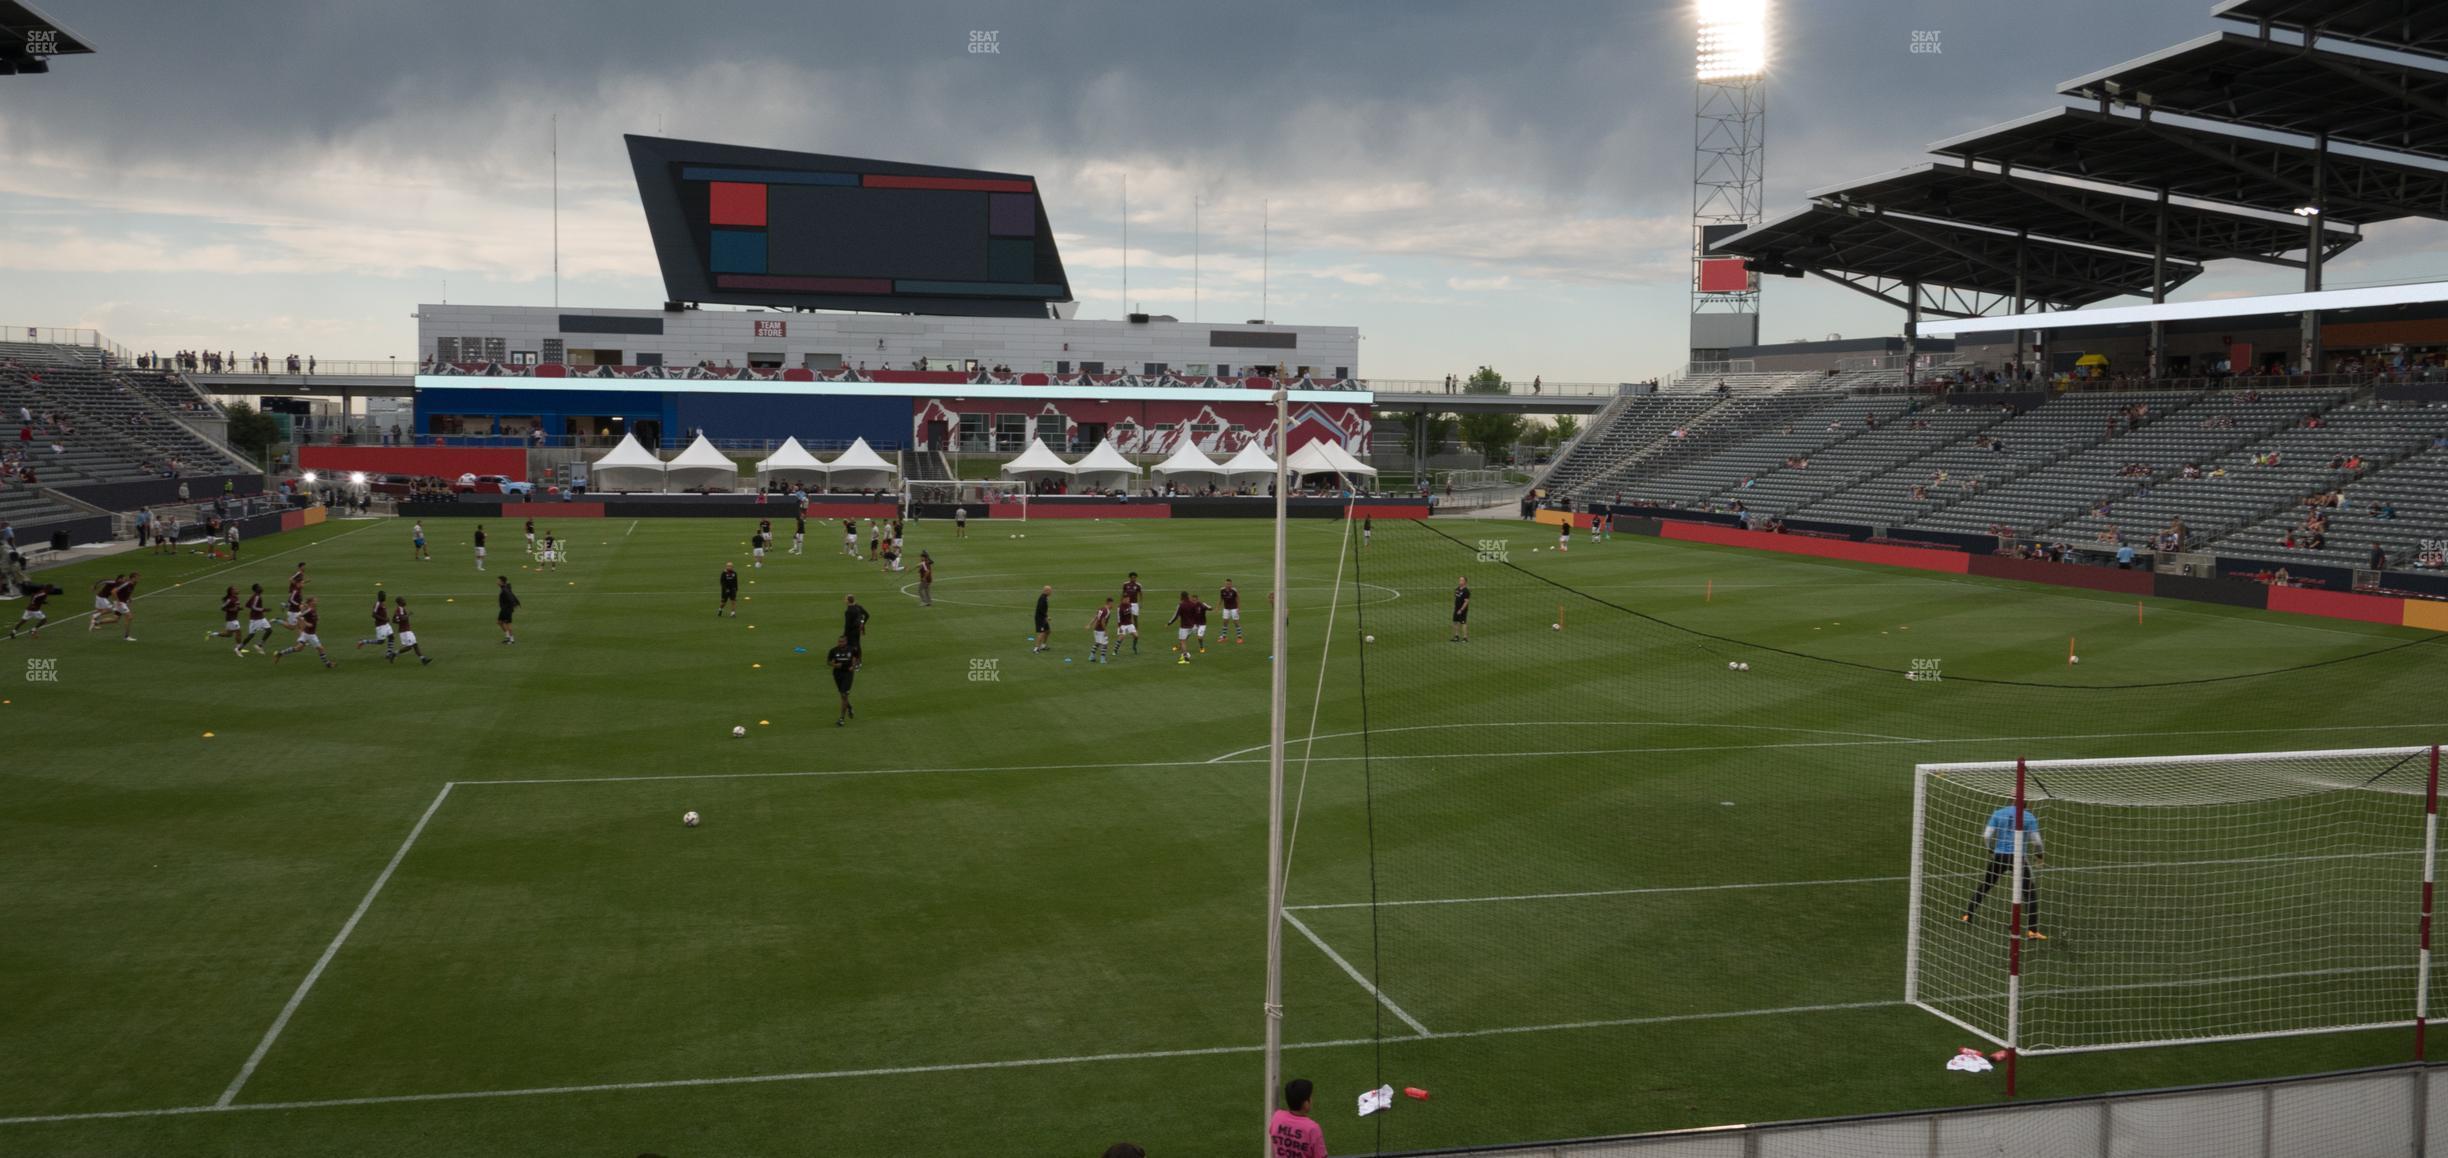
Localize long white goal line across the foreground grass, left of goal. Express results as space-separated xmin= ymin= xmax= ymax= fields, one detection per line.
xmin=0 ymin=999 xmax=1909 ymax=1126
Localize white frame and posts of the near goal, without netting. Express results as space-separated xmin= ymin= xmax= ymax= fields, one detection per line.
xmin=1905 ymin=744 xmax=2441 ymax=1094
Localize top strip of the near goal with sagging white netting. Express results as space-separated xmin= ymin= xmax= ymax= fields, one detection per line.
xmin=1912 ymin=744 xmax=2433 ymax=808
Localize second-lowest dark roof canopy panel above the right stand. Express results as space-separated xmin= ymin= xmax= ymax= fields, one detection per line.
xmin=1809 ymin=162 xmax=2362 ymax=264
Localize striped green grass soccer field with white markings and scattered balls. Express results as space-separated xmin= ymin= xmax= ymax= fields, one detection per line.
xmin=0 ymin=519 xmax=2448 ymax=1156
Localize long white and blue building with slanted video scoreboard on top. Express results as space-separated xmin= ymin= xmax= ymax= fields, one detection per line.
xmin=414 ymin=137 xmax=1368 ymax=455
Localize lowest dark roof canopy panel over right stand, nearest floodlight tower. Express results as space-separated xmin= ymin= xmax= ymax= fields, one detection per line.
xmin=1714 ymin=203 xmax=2201 ymax=313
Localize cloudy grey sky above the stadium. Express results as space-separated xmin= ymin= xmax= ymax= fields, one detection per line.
xmin=0 ymin=0 xmax=2436 ymax=379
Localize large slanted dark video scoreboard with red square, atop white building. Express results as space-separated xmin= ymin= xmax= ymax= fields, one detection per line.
xmin=627 ymin=137 xmax=1072 ymax=318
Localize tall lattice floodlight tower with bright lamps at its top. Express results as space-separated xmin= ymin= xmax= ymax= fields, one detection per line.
xmin=1689 ymin=0 xmax=1767 ymax=362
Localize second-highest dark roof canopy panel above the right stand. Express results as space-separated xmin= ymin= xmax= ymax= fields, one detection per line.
xmin=2059 ymin=32 xmax=2448 ymax=157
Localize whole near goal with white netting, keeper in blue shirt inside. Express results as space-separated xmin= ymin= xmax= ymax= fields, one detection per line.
xmin=1905 ymin=747 xmax=2438 ymax=1053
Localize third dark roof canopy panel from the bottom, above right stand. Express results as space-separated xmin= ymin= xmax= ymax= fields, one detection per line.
xmin=1929 ymin=108 xmax=2448 ymax=225
